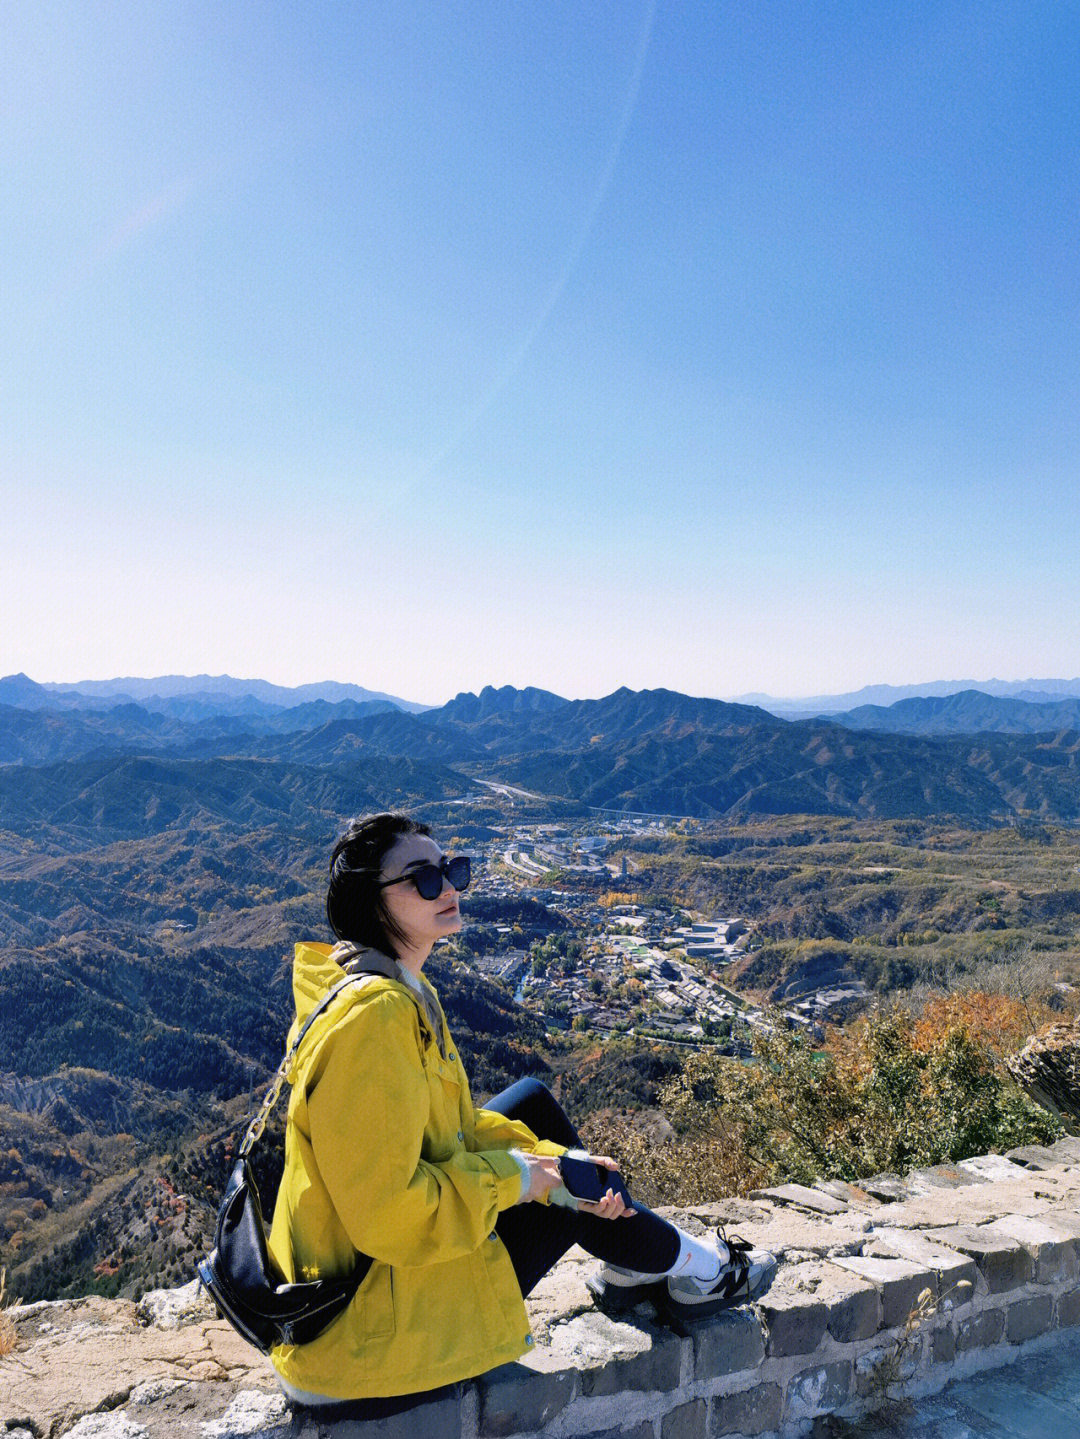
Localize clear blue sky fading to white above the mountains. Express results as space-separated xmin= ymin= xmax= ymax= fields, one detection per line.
xmin=0 ymin=0 xmax=1080 ymax=702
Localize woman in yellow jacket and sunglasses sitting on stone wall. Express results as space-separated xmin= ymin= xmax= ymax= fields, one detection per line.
xmin=270 ymin=814 xmax=775 ymax=1417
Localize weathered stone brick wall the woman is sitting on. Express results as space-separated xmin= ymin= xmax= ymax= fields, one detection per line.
xmin=0 ymin=1140 xmax=1080 ymax=1439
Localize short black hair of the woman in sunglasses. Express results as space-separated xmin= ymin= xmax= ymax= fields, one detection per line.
xmin=326 ymin=814 xmax=431 ymax=957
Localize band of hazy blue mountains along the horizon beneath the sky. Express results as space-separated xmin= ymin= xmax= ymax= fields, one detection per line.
xmin=0 ymin=675 xmax=1080 ymax=837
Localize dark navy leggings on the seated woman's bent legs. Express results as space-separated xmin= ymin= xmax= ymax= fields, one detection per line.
xmin=485 ymin=1079 xmax=679 ymax=1295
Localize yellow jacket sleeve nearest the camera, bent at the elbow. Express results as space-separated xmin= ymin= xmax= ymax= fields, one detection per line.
xmin=305 ymin=993 xmax=521 ymax=1266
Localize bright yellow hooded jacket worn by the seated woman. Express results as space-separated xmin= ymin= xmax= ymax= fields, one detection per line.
xmin=270 ymin=944 xmax=564 ymax=1399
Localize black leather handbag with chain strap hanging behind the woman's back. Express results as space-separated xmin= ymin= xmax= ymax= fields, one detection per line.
xmin=197 ymin=974 xmax=371 ymax=1354
